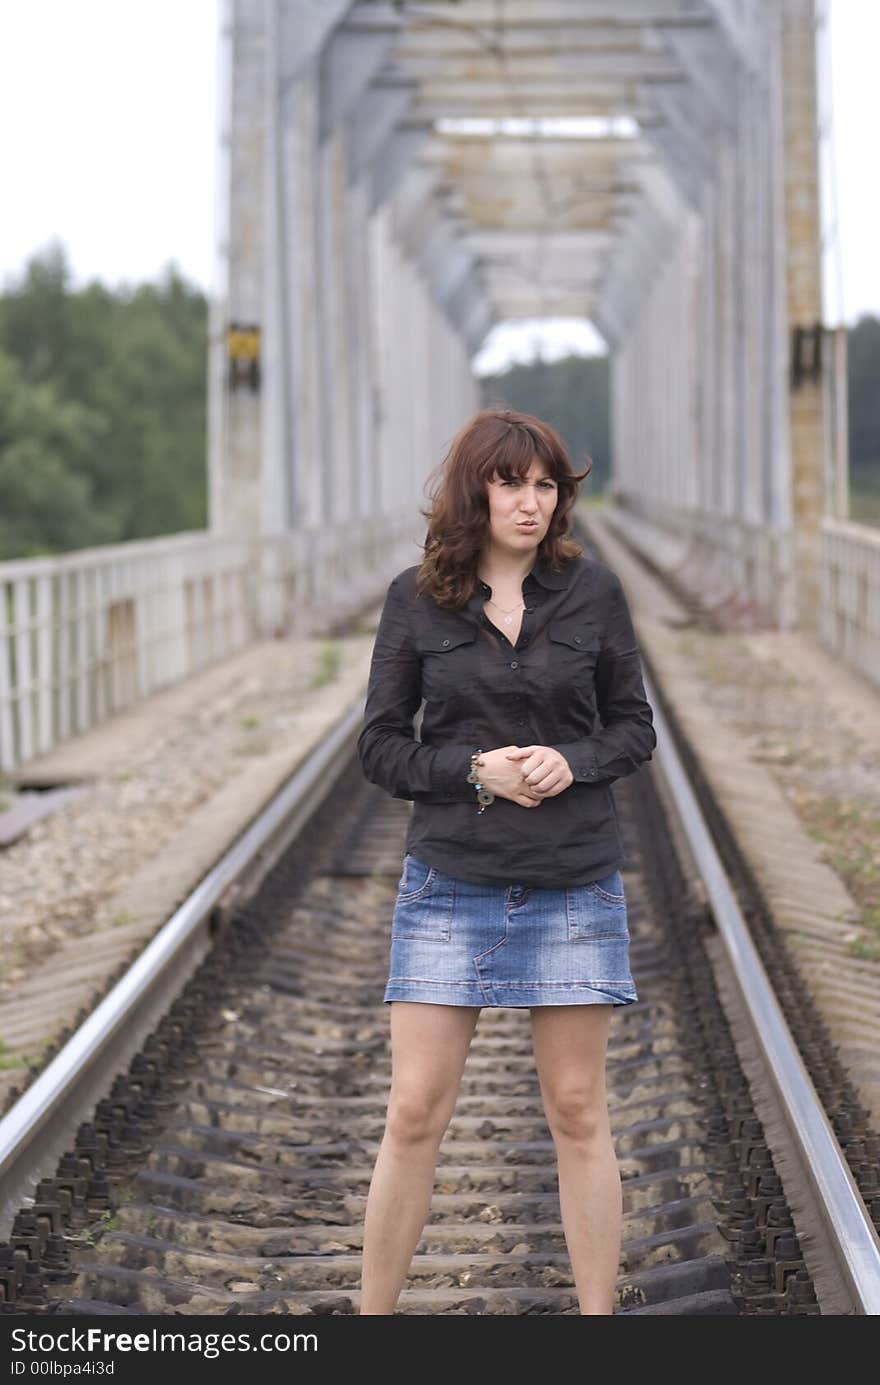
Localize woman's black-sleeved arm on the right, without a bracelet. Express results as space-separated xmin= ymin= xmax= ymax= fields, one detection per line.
xmin=553 ymin=572 xmax=657 ymax=784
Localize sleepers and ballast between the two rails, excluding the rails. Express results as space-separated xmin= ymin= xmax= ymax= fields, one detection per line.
xmin=0 ymin=720 xmax=866 ymax=1316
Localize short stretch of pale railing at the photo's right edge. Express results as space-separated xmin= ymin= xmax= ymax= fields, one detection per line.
xmin=820 ymin=518 xmax=880 ymax=687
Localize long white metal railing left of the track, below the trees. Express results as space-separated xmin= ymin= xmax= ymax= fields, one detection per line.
xmin=0 ymin=507 xmax=420 ymax=771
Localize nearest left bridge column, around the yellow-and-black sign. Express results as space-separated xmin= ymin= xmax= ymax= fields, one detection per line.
xmin=209 ymin=0 xmax=349 ymax=536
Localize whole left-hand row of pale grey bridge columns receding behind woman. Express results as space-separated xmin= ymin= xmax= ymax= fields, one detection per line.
xmin=209 ymin=0 xmax=477 ymax=630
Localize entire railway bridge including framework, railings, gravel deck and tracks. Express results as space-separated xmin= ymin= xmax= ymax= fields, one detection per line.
xmin=0 ymin=0 xmax=880 ymax=1316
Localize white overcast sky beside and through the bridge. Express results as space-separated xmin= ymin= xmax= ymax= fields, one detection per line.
xmin=0 ymin=0 xmax=880 ymax=370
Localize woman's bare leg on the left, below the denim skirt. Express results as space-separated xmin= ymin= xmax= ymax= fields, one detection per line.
xmin=360 ymin=1000 xmax=479 ymax=1314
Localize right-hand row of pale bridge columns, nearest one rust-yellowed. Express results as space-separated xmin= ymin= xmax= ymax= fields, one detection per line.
xmin=601 ymin=0 xmax=833 ymax=626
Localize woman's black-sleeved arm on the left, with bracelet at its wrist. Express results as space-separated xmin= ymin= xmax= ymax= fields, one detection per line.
xmin=358 ymin=578 xmax=477 ymax=801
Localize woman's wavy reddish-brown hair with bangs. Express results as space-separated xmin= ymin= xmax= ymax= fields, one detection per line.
xmin=416 ymin=407 xmax=593 ymax=611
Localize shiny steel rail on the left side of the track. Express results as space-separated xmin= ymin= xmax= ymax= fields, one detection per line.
xmin=0 ymin=698 xmax=364 ymax=1240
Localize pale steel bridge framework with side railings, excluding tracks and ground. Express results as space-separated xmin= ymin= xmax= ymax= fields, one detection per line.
xmin=0 ymin=0 xmax=880 ymax=770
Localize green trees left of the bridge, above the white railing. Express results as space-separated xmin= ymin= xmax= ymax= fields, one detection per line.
xmin=0 ymin=244 xmax=208 ymax=558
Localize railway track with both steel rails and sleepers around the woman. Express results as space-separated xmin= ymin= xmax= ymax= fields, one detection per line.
xmin=0 ymin=523 xmax=880 ymax=1316
